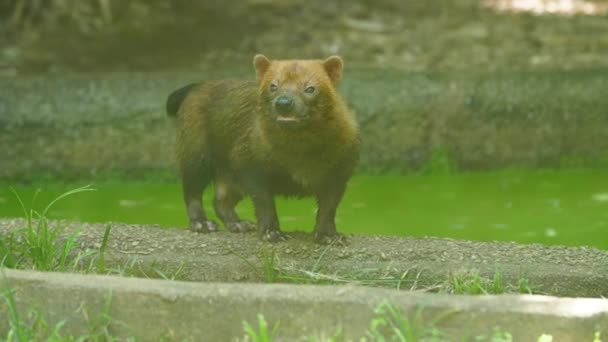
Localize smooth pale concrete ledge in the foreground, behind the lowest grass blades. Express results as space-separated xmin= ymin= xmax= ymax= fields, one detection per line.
xmin=0 ymin=269 xmax=608 ymax=341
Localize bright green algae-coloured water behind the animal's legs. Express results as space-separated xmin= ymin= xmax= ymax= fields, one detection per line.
xmin=0 ymin=169 xmax=608 ymax=249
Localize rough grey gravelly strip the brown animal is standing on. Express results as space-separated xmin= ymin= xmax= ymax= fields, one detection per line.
xmin=0 ymin=219 xmax=608 ymax=297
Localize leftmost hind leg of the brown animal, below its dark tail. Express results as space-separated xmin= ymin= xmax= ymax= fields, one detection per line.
xmin=181 ymin=158 xmax=217 ymax=233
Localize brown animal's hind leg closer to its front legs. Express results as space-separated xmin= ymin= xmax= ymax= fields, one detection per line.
xmin=213 ymin=178 xmax=256 ymax=233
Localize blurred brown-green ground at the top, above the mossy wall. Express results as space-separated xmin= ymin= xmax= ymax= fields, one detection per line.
xmin=0 ymin=0 xmax=608 ymax=73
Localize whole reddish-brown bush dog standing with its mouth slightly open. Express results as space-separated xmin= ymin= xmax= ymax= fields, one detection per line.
xmin=167 ymin=55 xmax=358 ymax=241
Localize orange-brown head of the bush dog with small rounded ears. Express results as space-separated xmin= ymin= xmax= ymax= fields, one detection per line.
xmin=253 ymin=55 xmax=344 ymax=128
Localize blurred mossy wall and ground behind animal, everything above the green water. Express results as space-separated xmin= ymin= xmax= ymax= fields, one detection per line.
xmin=0 ymin=0 xmax=608 ymax=181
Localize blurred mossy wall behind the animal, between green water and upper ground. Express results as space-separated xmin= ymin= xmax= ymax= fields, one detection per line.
xmin=0 ymin=68 xmax=608 ymax=181
